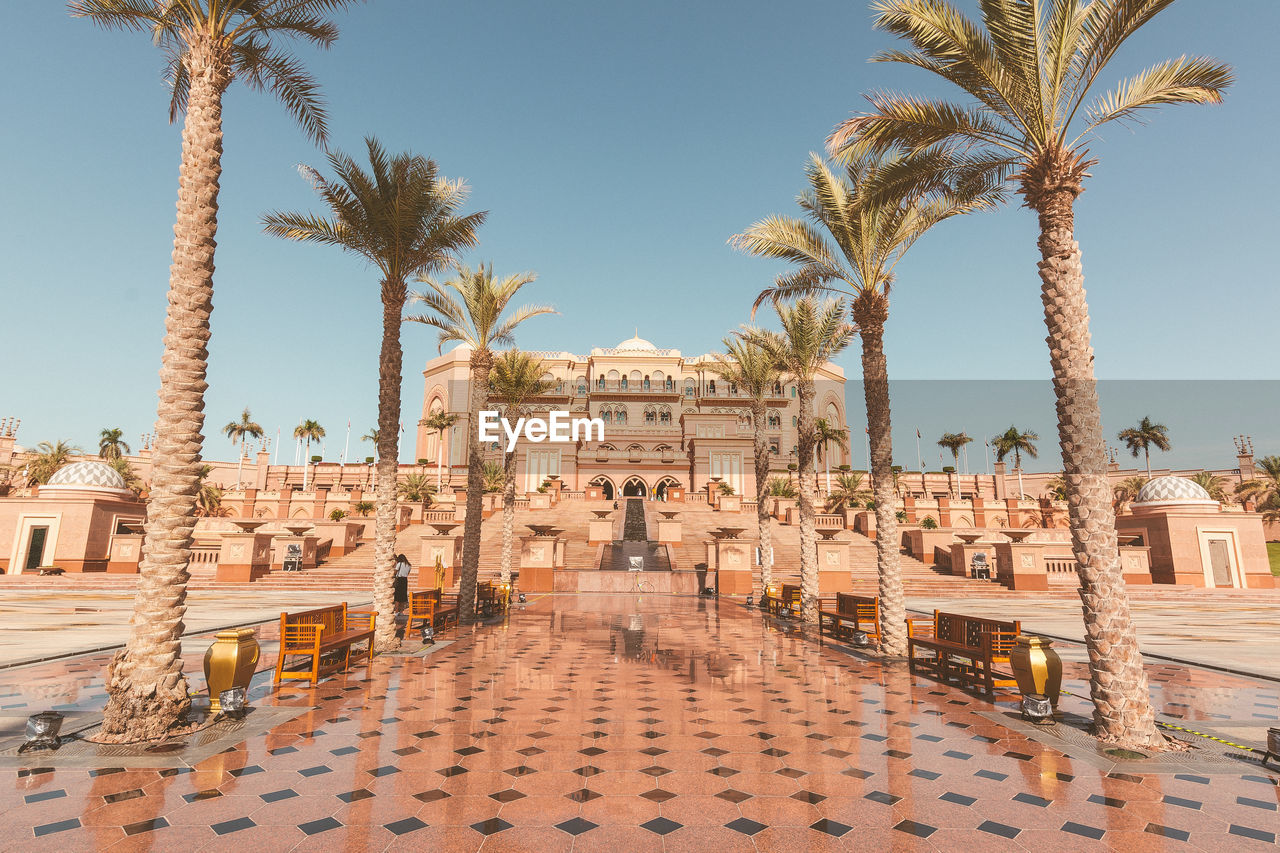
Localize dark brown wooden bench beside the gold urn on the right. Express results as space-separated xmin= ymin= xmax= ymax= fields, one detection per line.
xmin=906 ymin=610 xmax=1021 ymax=695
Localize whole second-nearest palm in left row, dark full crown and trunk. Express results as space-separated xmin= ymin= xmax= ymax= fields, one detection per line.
xmin=264 ymin=137 xmax=485 ymax=649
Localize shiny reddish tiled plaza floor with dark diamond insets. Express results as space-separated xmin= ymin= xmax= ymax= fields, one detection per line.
xmin=0 ymin=596 xmax=1280 ymax=853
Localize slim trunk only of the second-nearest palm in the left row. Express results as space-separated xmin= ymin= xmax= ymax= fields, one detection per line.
xmin=374 ymin=279 xmax=407 ymax=652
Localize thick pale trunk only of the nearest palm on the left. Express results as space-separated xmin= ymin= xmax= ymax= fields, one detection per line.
xmin=102 ymin=40 xmax=229 ymax=742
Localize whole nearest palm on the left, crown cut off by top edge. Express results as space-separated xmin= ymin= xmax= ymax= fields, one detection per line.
xmin=69 ymin=0 xmax=356 ymax=740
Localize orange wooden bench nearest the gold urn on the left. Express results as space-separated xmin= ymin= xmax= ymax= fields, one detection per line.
xmin=275 ymin=602 xmax=378 ymax=686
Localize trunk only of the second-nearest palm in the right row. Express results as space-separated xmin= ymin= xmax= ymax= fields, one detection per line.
xmin=854 ymin=293 xmax=906 ymax=657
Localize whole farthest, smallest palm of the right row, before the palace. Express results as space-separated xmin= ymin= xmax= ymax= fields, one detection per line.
xmin=703 ymin=333 xmax=782 ymax=597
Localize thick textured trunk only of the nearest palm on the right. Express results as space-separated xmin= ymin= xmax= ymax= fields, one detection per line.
xmin=1029 ymin=188 xmax=1164 ymax=749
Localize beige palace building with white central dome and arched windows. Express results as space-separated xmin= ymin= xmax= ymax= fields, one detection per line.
xmin=417 ymin=337 xmax=850 ymax=500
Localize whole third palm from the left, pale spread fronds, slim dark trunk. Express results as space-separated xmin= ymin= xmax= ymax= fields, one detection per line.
xmin=404 ymin=264 xmax=556 ymax=622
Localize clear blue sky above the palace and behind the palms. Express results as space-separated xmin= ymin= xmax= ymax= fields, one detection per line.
xmin=0 ymin=0 xmax=1280 ymax=467
